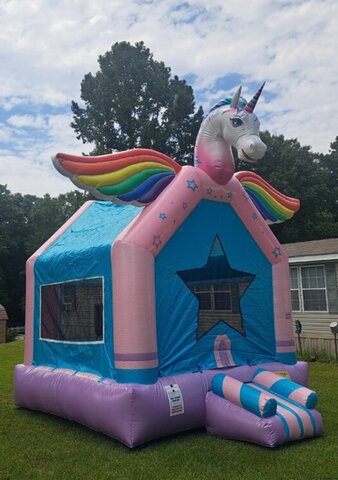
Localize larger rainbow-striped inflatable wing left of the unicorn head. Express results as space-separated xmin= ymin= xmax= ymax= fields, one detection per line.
xmin=52 ymin=148 xmax=182 ymax=206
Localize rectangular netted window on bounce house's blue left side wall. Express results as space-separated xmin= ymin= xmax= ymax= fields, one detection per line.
xmin=41 ymin=277 xmax=103 ymax=342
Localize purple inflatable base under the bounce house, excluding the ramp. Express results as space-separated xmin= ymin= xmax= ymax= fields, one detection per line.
xmin=14 ymin=362 xmax=308 ymax=447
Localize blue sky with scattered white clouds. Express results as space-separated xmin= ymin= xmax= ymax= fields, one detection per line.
xmin=0 ymin=0 xmax=338 ymax=196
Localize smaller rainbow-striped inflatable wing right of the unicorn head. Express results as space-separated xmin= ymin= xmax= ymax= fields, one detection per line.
xmin=235 ymin=172 xmax=300 ymax=224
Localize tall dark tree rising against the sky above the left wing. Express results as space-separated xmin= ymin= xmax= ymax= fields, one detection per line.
xmin=71 ymin=42 xmax=203 ymax=163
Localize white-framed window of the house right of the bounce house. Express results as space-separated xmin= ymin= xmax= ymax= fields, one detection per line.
xmin=290 ymin=265 xmax=327 ymax=312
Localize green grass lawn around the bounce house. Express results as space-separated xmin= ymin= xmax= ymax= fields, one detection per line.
xmin=0 ymin=341 xmax=338 ymax=480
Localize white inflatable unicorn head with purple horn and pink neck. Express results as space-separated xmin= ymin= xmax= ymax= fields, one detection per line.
xmin=195 ymin=84 xmax=266 ymax=185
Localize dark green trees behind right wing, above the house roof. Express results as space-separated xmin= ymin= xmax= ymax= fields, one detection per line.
xmin=238 ymin=132 xmax=338 ymax=243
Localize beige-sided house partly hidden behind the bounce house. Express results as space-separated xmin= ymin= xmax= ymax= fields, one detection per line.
xmin=283 ymin=238 xmax=338 ymax=356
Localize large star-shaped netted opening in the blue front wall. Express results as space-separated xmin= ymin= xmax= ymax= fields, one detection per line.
xmin=177 ymin=235 xmax=255 ymax=340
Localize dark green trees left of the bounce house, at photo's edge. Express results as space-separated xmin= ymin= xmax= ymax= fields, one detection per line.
xmin=0 ymin=185 xmax=88 ymax=323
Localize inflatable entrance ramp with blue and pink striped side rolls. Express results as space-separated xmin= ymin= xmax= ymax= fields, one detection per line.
xmin=206 ymin=368 xmax=323 ymax=447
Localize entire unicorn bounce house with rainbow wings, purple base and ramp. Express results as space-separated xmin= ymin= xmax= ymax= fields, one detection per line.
xmin=15 ymin=87 xmax=323 ymax=447
